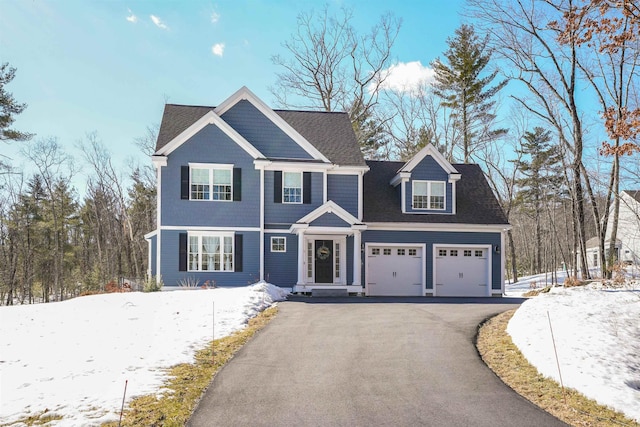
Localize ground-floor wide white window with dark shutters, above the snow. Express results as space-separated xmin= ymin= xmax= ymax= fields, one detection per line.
xmin=187 ymin=234 xmax=234 ymax=271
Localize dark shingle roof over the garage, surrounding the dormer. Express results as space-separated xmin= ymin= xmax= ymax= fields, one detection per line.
xmin=363 ymin=161 xmax=508 ymax=225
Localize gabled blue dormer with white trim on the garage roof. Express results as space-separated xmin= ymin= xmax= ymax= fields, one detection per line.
xmin=390 ymin=144 xmax=460 ymax=215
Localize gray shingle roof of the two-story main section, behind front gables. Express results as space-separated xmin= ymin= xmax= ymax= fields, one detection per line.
xmin=156 ymin=104 xmax=366 ymax=166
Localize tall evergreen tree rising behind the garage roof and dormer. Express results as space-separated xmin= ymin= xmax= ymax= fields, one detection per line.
xmin=431 ymin=25 xmax=507 ymax=163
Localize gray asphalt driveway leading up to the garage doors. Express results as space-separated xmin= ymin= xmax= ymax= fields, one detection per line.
xmin=188 ymin=298 xmax=565 ymax=427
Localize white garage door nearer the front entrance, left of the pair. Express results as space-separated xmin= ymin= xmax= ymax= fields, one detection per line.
xmin=366 ymin=245 xmax=424 ymax=296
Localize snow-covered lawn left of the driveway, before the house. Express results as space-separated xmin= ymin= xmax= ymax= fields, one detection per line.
xmin=0 ymin=283 xmax=286 ymax=426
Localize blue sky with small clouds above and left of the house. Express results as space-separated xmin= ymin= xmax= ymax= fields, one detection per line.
xmin=0 ymin=0 xmax=464 ymax=187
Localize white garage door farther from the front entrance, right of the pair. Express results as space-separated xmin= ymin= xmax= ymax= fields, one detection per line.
xmin=434 ymin=247 xmax=489 ymax=297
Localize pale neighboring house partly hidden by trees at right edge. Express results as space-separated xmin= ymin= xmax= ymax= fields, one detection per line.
xmin=587 ymin=190 xmax=640 ymax=268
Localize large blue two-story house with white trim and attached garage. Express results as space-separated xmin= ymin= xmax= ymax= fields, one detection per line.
xmin=146 ymin=87 xmax=509 ymax=296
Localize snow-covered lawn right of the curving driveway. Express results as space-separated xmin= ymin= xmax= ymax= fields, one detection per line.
xmin=507 ymin=277 xmax=640 ymax=421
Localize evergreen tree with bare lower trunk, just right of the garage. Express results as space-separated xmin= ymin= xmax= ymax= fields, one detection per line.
xmin=514 ymin=127 xmax=563 ymax=273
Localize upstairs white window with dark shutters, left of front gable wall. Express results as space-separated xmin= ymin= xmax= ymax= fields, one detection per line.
xmin=190 ymin=165 xmax=233 ymax=201
